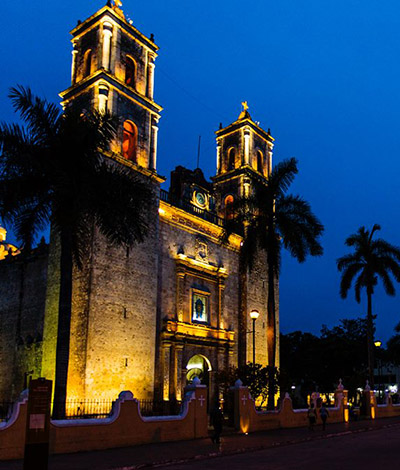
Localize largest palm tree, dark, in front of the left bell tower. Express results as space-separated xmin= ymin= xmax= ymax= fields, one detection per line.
xmin=0 ymin=86 xmax=152 ymax=418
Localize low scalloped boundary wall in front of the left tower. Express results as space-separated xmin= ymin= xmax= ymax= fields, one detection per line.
xmin=0 ymin=385 xmax=208 ymax=460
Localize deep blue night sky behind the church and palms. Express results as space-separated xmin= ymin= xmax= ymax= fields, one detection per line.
xmin=0 ymin=0 xmax=400 ymax=340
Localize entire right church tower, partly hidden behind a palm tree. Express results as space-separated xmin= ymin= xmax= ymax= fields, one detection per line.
xmin=213 ymin=102 xmax=279 ymax=365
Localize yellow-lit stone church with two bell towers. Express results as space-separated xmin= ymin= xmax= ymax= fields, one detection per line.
xmin=0 ymin=1 xmax=279 ymax=401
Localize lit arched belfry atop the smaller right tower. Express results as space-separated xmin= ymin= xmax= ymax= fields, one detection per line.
xmin=213 ymin=101 xmax=274 ymax=217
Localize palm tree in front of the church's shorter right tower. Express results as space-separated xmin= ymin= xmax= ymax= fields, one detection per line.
xmin=227 ymin=158 xmax=324 ymax=408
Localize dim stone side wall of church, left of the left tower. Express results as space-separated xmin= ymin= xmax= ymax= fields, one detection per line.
xmin=0 ymin=244 xmax=48 ymax=400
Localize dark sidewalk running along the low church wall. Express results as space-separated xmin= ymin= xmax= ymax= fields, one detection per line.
xmin=0 ymin=417 xmax=400 ymax=470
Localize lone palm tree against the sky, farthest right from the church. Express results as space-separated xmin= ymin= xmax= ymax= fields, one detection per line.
xmin=337 ymin=224 xmax=400 ymax=386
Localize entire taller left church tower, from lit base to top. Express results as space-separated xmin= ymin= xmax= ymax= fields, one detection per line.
xmin=42 ymin=0 xmax=164 ymax=400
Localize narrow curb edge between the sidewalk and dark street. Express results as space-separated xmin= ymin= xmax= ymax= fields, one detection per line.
xmin=109 ymin=423 xmax=400 ymax=470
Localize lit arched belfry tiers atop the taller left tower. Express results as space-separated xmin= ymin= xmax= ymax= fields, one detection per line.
xmin=60 ymin=0 xmax=162 ymax=174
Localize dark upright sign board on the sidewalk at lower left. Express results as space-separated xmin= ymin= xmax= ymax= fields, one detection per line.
xmin=24 ymin=378 xmax=52 ymax=470
